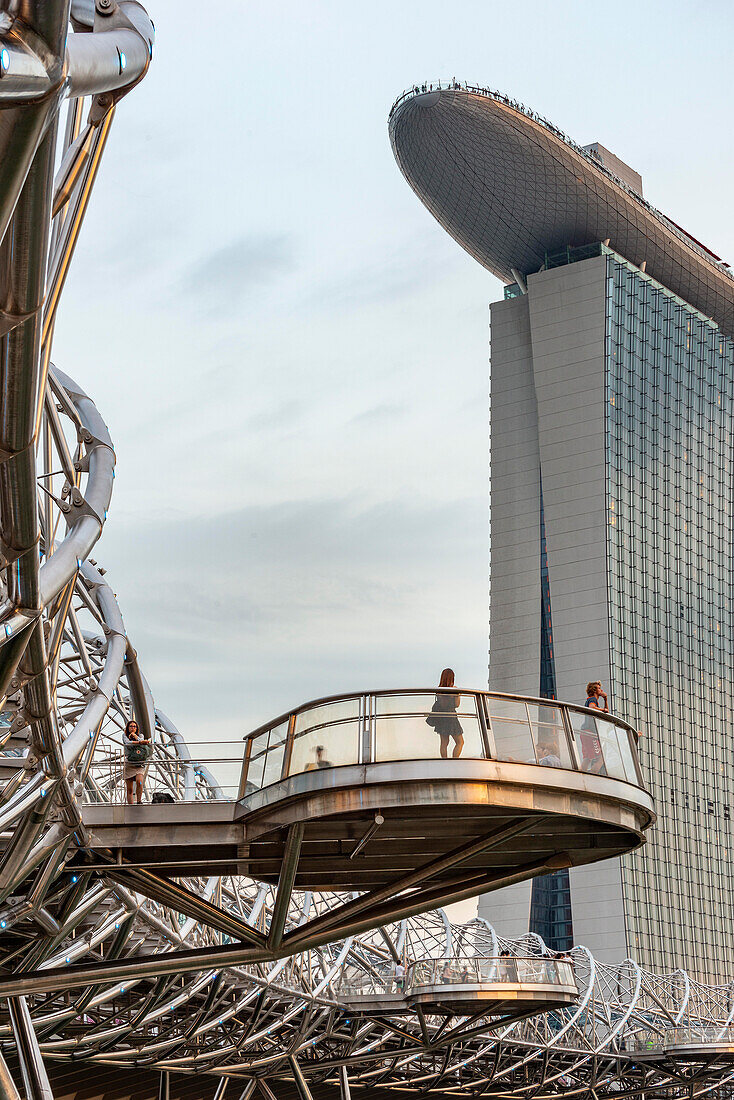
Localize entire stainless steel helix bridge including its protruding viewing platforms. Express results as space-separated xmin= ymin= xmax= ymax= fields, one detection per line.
xmin=0 ymin=0 xmax=734 ymax=1100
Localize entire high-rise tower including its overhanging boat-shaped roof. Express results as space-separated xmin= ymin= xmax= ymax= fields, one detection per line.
xmin=390 ymin=84 xmax=734 ymax=981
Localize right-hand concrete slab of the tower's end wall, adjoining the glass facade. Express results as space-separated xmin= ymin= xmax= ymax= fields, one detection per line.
xmin=528 ymin=256 xmax=627 ymax=963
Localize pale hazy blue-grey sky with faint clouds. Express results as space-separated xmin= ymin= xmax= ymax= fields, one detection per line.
xmin=54 ymin=0 xmax=734 ymax=738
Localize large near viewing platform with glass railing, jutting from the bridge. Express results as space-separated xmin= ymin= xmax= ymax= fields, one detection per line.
xmin=84 ymin=689 xmax=655 ymax=938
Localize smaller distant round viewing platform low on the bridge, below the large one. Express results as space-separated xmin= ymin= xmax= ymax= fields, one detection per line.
xmin=337 ymin=956 xmax=579 ymax=1021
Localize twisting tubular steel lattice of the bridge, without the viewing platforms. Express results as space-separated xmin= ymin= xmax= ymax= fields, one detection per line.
xmin=0 ymin=8 xmax=734 ymax=1100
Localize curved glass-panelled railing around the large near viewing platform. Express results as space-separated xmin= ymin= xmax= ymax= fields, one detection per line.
xmin=240 ymin=688 xmax=644 ymax=796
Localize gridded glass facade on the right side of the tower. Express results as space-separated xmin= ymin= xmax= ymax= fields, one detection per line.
xmin=605 ymin=254 xmax=734 ymax=981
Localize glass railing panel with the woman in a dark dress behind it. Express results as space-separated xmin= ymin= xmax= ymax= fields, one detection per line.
xmin=374 ymin=711 xmax=485 ymax=761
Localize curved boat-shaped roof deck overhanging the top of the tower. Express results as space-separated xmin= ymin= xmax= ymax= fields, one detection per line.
xmin=390 ymin=83 xmax=734 ymax=336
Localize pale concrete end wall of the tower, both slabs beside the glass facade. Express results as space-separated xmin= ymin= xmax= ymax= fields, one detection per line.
xmin=479 ymin=256 xmax=627 ymax=963
